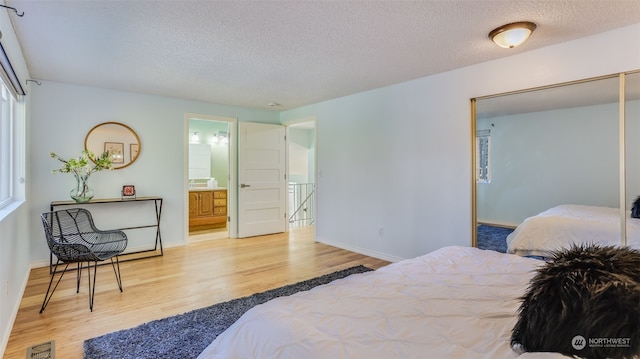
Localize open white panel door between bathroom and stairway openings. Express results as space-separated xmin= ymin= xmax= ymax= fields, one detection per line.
xmin=238 ymin=122 xmax=287 ymax=238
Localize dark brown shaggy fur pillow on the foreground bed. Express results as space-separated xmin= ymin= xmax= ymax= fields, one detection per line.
xmin=511 ymin=245 xmax=640 ymax=359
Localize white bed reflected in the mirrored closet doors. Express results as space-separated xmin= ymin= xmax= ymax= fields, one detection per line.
xmin=507 ymin=204 xmax=640 ymax=257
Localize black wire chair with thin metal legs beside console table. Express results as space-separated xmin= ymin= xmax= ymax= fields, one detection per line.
xmin=40 ymin=208 xmax=127 ymax=313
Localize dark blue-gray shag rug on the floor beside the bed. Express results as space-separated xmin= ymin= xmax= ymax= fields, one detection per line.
xmin=83 ymin=266 xmax=371 ymax=359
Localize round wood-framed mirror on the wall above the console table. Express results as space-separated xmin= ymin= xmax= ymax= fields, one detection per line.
xmin=84 ymin=122 xmax=141 ymax=170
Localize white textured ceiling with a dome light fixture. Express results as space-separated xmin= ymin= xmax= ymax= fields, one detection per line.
xmin=5 ymin=0 xmax=640 ymax=111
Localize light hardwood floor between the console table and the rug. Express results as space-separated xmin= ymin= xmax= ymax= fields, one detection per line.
xmin=4 ymin=227 xmax=388 ymax=359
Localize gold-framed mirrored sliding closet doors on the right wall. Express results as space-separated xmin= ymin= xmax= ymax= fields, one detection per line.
xmin=472 ymin=72 xmax=640 ymax=252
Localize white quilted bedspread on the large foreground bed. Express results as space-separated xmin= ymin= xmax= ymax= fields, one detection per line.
xmin=199 ymin=247 xmax=565 ymax=359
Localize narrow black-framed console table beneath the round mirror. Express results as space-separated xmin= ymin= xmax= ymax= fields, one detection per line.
xmin=49 ymin=196 xmax=164 ymax=272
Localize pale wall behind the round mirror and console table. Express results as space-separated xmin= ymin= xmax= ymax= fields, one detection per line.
xmin=30 ymin=81 xmax=278 ymax=265
